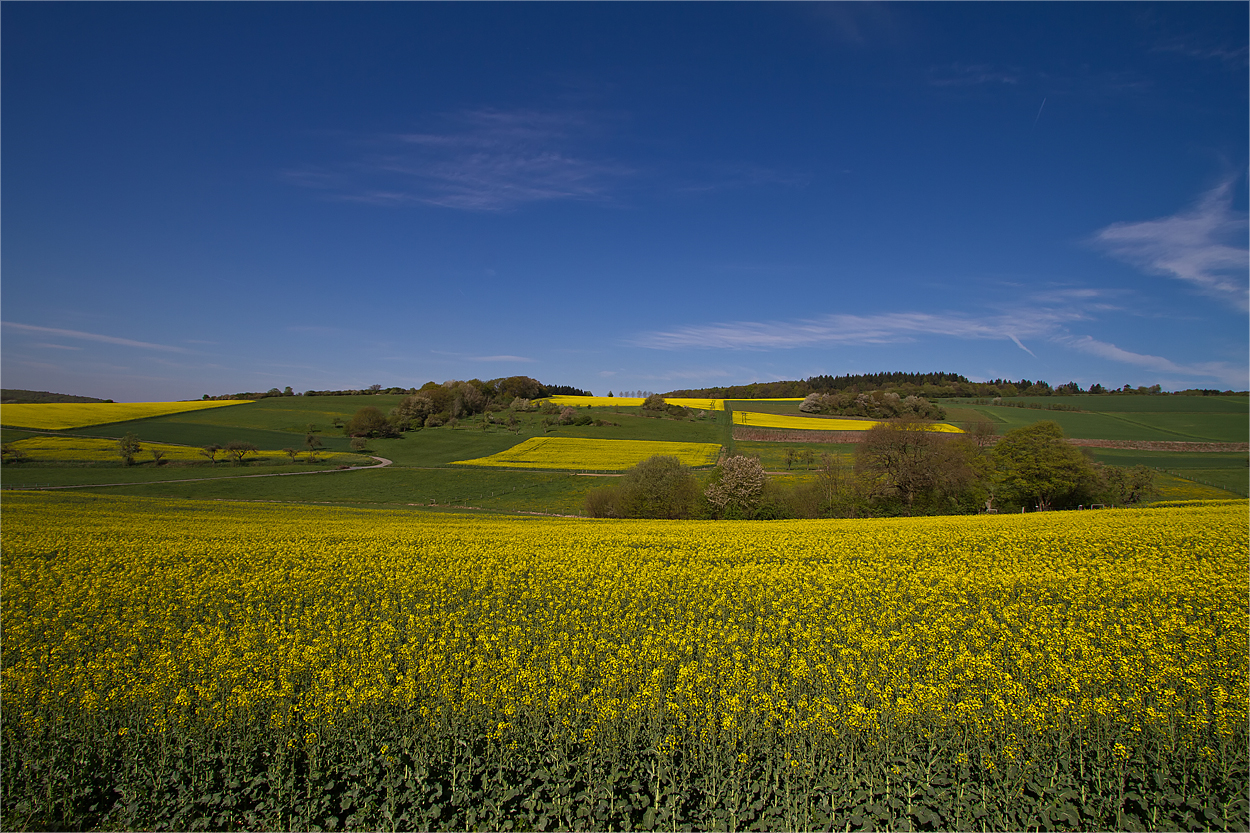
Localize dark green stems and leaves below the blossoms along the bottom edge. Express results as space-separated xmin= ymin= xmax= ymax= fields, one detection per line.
xmin=7 ymin=710 xmax=1250 ymax=830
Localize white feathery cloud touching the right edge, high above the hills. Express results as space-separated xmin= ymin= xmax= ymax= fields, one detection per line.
xmin=1093 ymin=180 xmax=1250 ymax=311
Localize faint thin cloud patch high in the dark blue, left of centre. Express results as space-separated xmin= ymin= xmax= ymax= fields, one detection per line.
xmin=288 ymin=109 xmax=633 ymax=211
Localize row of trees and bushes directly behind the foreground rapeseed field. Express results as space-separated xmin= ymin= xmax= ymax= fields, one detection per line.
xmin=586 ymin=419 xmax=1158 ymax=519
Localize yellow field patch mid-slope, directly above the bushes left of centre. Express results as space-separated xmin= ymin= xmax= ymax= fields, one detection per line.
xmin=454 ymin=437 xmax=720 ymax=472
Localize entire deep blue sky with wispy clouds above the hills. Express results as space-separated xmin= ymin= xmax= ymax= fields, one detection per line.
xmin=0 ymin=3 xmax=1250 ymax=401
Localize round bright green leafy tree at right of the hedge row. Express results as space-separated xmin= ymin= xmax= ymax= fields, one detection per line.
xmin=993 ymin=419 xmax=1098 ymax=509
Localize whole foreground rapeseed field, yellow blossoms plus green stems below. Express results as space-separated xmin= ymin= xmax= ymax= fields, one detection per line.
xmin=0 ymin=493 xmax=1248 ymax=829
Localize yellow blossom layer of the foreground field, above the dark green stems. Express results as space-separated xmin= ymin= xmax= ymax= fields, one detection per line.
xmin=0 ymin=493 xmax=1248 ymax=757
